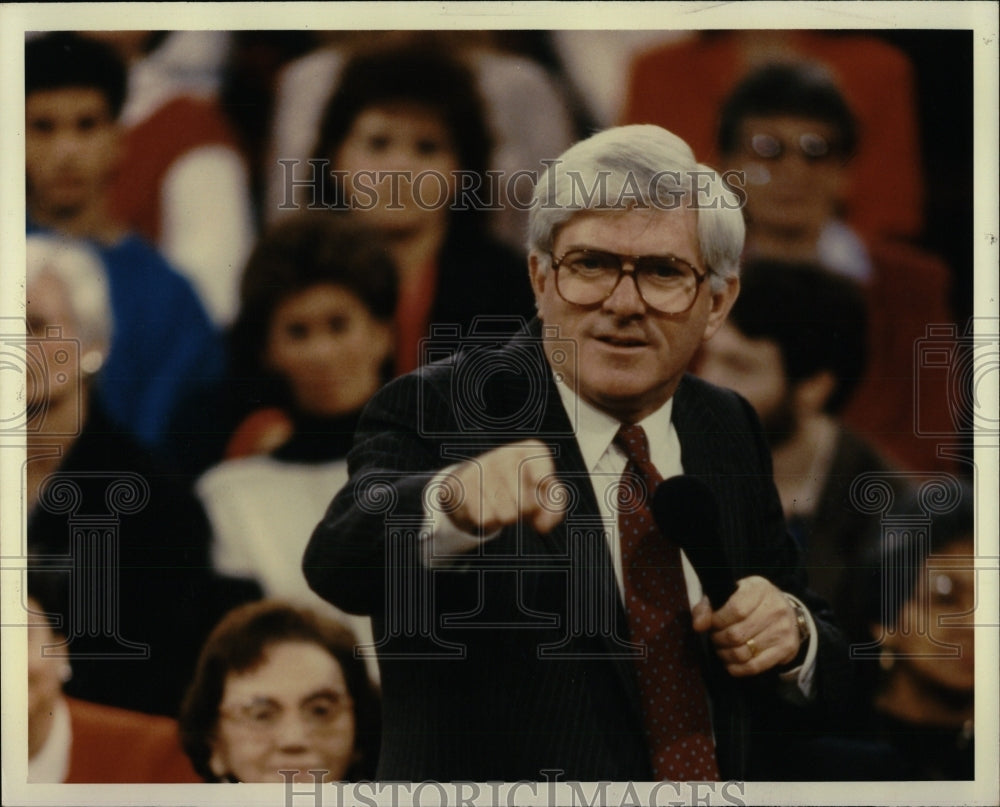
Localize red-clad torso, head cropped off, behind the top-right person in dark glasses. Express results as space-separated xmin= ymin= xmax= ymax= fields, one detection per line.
xmin=622 ymin=30 xmax=924 ymax=243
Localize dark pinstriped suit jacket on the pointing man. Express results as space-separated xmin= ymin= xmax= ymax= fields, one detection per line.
xmin=303 ymin=322 xmax=847 ymax=781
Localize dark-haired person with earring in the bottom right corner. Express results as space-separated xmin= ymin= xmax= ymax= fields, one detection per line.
xmin=865 ymin=488 xmax=977 ymax=780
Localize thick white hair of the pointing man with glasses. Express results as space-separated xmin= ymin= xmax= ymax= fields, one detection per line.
xmin=528 ymin=124 xmax=746 ymax=291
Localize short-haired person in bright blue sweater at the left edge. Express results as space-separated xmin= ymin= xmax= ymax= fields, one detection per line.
xmin=25 ymin=33 xmax=225 ymax=474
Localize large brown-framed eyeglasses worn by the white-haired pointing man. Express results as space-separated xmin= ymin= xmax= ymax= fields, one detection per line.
xmin=549 ymin=249 xmax=708 ymax=314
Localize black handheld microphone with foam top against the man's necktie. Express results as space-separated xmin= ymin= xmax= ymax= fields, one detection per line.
xmin=650 ymin=476 xmax=736 ymax=610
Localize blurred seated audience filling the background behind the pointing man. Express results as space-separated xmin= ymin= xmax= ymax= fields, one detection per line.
xmin=24 ymin=30 xmax=975 ymax=782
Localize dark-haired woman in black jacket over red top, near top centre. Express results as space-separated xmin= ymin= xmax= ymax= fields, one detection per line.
xmin=314 ymin=40 xmax=534 ymax=373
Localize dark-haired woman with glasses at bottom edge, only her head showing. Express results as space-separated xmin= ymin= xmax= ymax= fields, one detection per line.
xmin=180 ymin=600 xmax=381 ymax=782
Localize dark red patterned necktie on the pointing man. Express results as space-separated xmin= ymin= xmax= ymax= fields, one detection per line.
xmin=615 ymin=424 xmax=719 ymax=781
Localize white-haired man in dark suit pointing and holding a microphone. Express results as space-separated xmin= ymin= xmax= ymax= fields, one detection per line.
xmin=303 ymin=126 xmax=847 ymax=781
